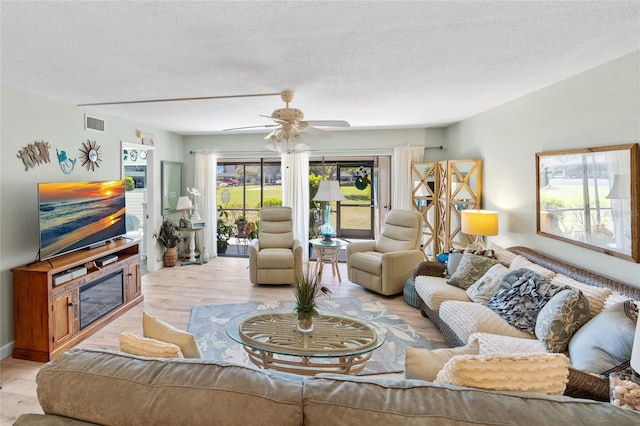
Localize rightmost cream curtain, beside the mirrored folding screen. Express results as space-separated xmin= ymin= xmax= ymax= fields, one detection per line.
xmin=391 ymin=145 xmax=424 ymax=210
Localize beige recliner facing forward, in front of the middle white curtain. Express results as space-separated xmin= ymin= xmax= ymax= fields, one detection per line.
xmin=249 ymin=207 xmax=302 ymax=284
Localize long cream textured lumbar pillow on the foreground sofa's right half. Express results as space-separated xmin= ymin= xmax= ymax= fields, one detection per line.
xmin=434 ymin=354 xmax=569 ymax=395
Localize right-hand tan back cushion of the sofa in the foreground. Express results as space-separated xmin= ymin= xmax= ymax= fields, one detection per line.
xmin=302 ymin=375 xmax=638 ymax=426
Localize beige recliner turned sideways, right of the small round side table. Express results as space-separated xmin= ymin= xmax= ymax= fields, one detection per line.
xmin=347 ymin=210 xmax=425 ymax=296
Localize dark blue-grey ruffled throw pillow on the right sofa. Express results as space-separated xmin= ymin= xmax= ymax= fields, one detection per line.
xmin=487 ymin=269 xmax=564 ymax=334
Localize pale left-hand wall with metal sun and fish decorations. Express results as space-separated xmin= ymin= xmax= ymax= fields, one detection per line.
xmin=0 ymin=85 xmax=182 ymax=358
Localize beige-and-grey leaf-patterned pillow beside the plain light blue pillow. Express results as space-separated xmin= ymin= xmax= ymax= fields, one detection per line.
xmin=536 ymin=288 xmax=591 ymax=352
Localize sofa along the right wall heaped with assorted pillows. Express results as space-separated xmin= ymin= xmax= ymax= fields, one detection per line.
xmin=414 ymin=245 xmax=640 ymax=401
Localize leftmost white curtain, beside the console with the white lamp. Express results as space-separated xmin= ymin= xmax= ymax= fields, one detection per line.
xmin=193 ymin=152 xmax=218 ymax=256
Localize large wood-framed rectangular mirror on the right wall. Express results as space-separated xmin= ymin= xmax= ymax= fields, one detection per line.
xmin=536 ymin=144 xmax=640 ymax=263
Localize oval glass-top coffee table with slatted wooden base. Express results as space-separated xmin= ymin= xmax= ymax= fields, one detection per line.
xmin=225 ymin=310 xmax=384 ymax=375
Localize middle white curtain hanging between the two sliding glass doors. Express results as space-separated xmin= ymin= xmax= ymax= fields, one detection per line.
xmin=281 ymin=152 xmax=309 ymax=263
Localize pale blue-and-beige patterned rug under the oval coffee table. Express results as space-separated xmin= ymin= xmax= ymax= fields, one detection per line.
xmin=188 ymin=297 xmax=431 ymax=375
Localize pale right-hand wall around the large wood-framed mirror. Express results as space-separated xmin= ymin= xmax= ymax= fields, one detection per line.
xmin=446 ymin=51 xmax=640 ymax=286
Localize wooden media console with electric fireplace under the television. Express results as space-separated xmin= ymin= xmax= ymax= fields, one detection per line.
xmin=11 ymin=239 xmax=144 ymax=362
